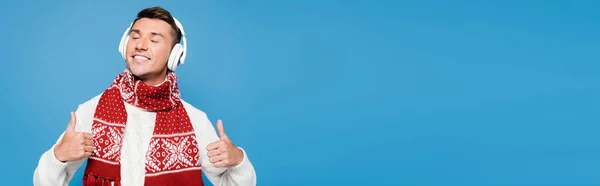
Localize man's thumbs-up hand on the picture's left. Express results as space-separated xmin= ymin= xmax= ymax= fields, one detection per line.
xmin=54 ymin=112 xmax=94 ymax=163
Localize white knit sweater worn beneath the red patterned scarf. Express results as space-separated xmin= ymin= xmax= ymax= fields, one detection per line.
xmin=33 ymin=95 xmax=256 ymax=186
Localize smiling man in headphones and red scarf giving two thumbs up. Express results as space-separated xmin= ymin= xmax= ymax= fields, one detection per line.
xmin=34 ymin=7 xmax=256 ymax=186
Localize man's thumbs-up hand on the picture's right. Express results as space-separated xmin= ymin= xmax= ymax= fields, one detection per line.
xmin=206 ymin=120 xmax=244 ymax=167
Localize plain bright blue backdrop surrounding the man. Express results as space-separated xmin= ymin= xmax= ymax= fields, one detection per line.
xmin=0 ymin=0 xmax=600 ymax=186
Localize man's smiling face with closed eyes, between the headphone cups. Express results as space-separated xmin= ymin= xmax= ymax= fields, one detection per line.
xmin=126 ymin=18 xmax=174 ymax=83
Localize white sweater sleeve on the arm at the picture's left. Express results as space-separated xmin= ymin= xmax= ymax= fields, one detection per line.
xmin=33 ymin=101 xmax=93 ymax=186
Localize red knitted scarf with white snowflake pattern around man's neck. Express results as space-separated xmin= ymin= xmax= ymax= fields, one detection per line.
xmin=83 ymin=69 xmax=203 ymax=186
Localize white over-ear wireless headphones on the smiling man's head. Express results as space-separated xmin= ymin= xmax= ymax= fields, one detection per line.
xmin=119 ymin=18 xmax=187 ymax=71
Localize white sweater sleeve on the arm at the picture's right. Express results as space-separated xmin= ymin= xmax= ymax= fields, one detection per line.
xmin=188 ymin=102 xmax=256 ymax=186
